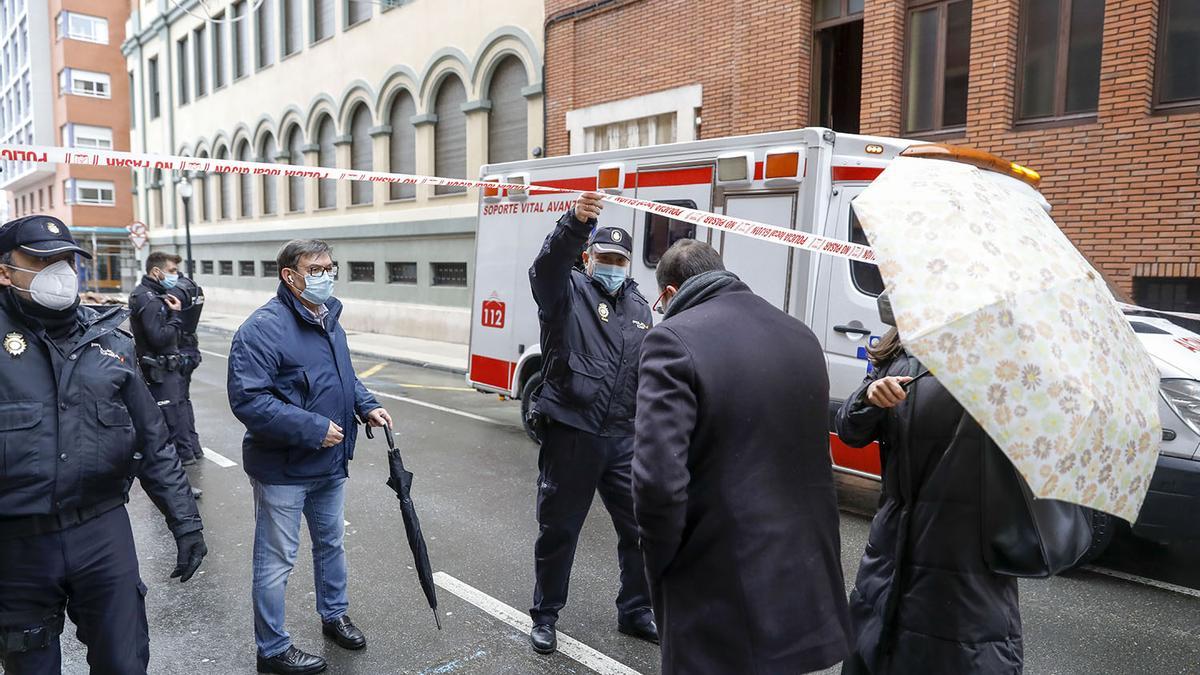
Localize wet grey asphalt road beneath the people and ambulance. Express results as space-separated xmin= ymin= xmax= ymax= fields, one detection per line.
xmin=44 ymin=324 xmax=1200 ymax=675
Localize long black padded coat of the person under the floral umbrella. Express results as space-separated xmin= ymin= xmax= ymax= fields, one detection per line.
xmin=836 ymin=354 xmax=1022 ymax=675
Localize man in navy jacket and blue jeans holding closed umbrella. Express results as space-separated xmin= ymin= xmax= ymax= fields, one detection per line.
xmin=228 ymin=240 xmax=391 ymax=675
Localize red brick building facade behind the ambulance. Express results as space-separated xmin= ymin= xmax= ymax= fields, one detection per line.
xmin=545 ymin=0 xmax=1200 ymax=312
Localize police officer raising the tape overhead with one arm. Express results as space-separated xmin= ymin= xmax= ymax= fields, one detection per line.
xmin=529 ymin=192 xmax=658 ymax=653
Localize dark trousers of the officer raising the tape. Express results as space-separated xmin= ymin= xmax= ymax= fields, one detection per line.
xmin=529 ymin=423 xmax=652 ymax=625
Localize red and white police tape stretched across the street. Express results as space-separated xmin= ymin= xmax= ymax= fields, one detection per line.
xmin=0 ymin=144 xmax=876 ymax=264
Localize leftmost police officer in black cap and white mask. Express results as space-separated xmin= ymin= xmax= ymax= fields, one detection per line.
xmin=0 ymin=215 xmax=208 ymax=675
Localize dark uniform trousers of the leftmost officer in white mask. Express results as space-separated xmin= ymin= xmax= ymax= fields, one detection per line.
xmin=0 ymin=507 xmax=150 ymax=675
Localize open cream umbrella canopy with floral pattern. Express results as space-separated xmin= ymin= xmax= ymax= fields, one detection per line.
xmin=853 ymin=157 xmax=1162 ymax=522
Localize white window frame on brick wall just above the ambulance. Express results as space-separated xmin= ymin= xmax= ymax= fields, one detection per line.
xmin=566 ymin=84 xmax=704 ymax=155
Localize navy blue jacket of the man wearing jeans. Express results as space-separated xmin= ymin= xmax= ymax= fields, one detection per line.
xmin=228 ymin=283 xmax=380 ymax=484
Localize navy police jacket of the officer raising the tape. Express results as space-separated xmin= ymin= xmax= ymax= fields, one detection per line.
xmin=529 ymin=210 xmax=650 ymax=437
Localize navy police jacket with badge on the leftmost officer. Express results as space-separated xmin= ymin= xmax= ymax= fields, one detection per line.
xmin=0 ymin=291 xmax=202 ymax=537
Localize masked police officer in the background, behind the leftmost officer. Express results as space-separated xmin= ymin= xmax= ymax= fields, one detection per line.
xmin=130 ymin=251 xmax=202 ymax=497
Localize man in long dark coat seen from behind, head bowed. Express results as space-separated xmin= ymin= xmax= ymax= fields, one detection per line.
xmin=634 ymin=239 xmax=851 ymax=675
